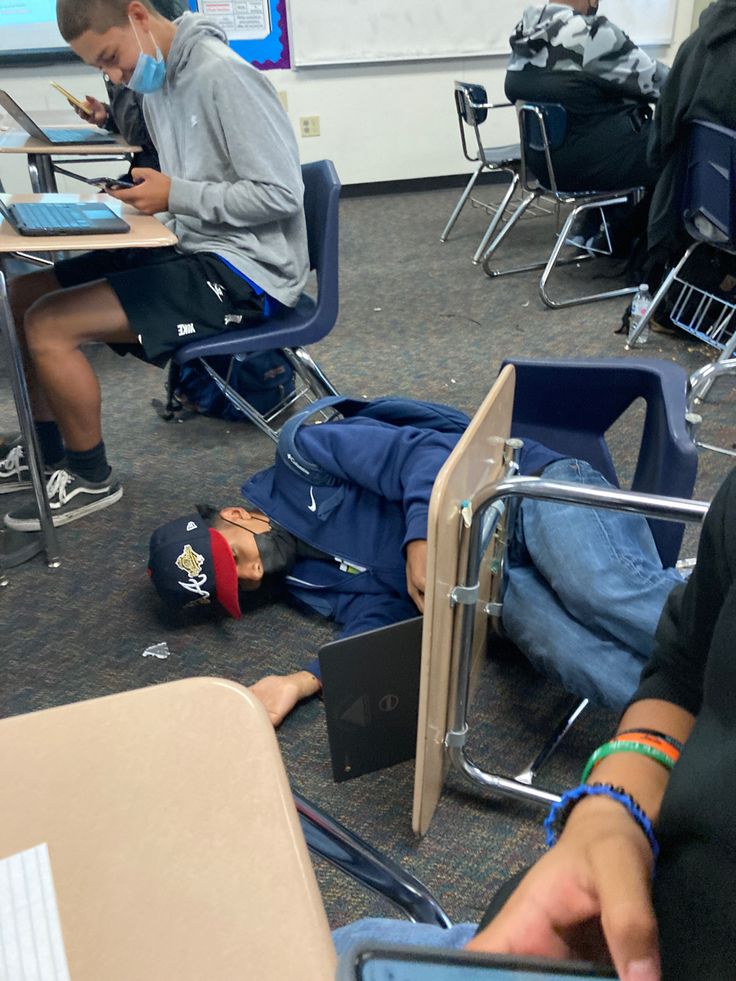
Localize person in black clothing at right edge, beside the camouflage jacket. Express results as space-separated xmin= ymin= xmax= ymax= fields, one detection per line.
xmin=646 ymin=0 xmax=736 ymax=286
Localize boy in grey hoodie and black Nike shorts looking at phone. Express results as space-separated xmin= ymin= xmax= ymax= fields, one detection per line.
xmin=0 ymin=0 xmax=309 ymax=531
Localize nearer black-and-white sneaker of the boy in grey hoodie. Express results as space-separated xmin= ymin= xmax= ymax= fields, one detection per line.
xmin=5 ymin=470 xmax=123 ymax=531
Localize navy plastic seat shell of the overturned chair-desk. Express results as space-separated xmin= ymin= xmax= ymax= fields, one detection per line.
xmin=504 ymin=358 xmax=698 ymax=566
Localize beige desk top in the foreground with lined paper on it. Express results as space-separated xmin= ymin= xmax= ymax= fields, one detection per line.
xmin=0 ymin=678 xmax=335 ymax=981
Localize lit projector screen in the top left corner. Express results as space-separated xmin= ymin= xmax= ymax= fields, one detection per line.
xmin=0 ymin=0 xmax=75 ymax=63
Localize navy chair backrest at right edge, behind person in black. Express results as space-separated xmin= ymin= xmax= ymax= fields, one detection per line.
xmin=683 ymin=121 xmax=736 ymax=250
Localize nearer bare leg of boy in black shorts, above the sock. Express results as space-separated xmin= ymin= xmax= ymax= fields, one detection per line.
xmin=24 ymin=280 xmax=138 ymax=452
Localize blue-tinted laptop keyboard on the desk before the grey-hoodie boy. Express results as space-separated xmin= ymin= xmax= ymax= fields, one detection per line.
xmin=0 ymin=201 xmax=130 ymax=236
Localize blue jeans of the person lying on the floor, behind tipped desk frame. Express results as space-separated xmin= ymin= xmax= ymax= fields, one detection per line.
xmin=502 ymin=459 xmax=682 ymax=711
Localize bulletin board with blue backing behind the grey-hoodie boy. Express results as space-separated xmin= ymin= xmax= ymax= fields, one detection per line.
xmin=189 ymin=0 xmax=291 ymax=69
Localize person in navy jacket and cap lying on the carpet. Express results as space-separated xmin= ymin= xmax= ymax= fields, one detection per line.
xmin=149 ymin=400 xmax=682 ymax=725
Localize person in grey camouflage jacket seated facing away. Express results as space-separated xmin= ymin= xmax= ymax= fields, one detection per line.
xmin=505 ymin=0 xmax=668 ymax=191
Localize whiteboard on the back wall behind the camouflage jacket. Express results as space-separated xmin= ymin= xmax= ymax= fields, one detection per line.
xmin=289 ymin=0 xmax=677 ymax=68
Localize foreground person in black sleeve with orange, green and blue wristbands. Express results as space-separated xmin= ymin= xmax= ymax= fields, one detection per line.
xmin=334 ymin=470 xmax=736 ymax=981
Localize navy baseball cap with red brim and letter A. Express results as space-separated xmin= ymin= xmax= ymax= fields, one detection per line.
xmin=148 ymin=514 xmax=241 ymax=620
